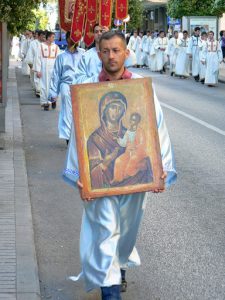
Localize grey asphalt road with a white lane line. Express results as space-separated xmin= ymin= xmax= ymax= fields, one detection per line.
xmin=17 ymin=69 xmax=225 ymax=300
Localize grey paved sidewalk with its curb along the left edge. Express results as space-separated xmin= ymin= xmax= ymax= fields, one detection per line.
xmin=0 ymin=62 xmax=41 ymax=300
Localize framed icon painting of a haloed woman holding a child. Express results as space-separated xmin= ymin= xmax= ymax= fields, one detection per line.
xmin=71 ymin=78 xmax=164 ymax=199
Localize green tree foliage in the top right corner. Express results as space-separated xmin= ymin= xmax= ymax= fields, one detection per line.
xmin=167 ymin=0 xmax=225 ymax=18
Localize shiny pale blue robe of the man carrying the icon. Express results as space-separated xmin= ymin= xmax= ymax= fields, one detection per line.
xmin=63 ymin=74 xmax=176 ymax=291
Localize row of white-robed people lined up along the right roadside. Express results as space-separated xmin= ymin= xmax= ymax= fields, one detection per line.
xmin=128 ymin=27 xmax=225 ymax=87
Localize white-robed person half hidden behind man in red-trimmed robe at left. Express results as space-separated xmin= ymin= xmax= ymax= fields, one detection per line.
xmin=25 ymin=30 xmax=45 ymax=97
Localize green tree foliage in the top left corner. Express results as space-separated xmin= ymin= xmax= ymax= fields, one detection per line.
xmin=0 ymin=0 xmax=47 ymax=35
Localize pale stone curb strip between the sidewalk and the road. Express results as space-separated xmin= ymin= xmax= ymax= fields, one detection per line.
xmin=9 ymin=62 xmax=41 ymax=300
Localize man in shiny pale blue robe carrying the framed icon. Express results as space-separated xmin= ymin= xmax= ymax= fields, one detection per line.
xmin=63 ymin=31 xmax=176 ymax=300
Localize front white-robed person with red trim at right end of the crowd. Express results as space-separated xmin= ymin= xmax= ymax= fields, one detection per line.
xmin=201 ymin=31 xmax=223 ymax=87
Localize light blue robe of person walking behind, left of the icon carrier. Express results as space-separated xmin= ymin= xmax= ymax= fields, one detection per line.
xmin=48 ymin=48 xmax=85 ymax=140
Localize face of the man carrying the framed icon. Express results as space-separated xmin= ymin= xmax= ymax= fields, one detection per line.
xmin=99 ymin=36 xmax=129 ymax=74
